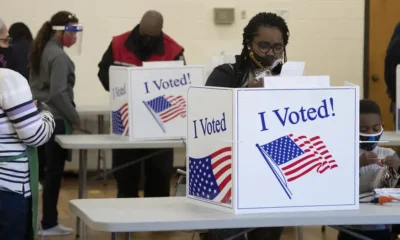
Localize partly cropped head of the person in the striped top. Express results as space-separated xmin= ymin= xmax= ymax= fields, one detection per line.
xmin=0 ymin=19 xmax=17 ymax=71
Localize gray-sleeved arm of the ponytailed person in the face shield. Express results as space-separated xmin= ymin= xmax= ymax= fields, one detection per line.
xmin=49 ymin=54 xmax=80 ymax=125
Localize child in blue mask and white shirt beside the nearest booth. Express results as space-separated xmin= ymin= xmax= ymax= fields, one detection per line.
xmin=338 ymin=99 xmax=400 ymax=240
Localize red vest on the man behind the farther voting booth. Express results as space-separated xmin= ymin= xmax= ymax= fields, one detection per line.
xmin=112 ymin=31 xmax=183 ymax=66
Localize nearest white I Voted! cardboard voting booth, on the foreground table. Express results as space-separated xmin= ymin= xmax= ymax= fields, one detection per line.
xmin=186 ymin=77 xmax=359 ymax=214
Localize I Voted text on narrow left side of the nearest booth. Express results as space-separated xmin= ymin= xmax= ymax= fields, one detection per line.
xmin=193 ymin=113 xmax=226 ymax=138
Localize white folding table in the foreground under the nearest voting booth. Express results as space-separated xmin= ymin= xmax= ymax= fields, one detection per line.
xmin=69 ymin=197 xmax=400 ymax=239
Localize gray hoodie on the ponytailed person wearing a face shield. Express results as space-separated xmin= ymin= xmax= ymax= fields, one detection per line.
xmin=29 ymin=39 xmax=79 ymax=124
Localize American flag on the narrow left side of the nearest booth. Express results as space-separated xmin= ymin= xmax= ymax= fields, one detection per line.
xmin=189 ymin=147 xmax=232 ymax=204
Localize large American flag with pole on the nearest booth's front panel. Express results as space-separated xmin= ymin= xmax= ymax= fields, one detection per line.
xmin=257 ymin=134 xmax=338 ymax=198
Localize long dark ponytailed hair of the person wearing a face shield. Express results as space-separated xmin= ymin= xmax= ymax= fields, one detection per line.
xmin=29 ymin=11 xmax=79 ymax=75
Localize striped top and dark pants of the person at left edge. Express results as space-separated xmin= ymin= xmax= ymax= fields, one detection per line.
xmin=0 ymin=68 xmax=55 ymax=240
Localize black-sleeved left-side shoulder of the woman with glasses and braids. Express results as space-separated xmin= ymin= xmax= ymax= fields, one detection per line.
xmin=206 ymin=64 xmax=235 ymax=87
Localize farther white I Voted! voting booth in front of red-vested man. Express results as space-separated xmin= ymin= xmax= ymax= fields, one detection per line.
xmin=110 ymin=66 xmax=204 ymax=140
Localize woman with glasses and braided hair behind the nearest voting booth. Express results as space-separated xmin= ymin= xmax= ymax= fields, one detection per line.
xmin=205 ymin=12 xmax=289 ymax=240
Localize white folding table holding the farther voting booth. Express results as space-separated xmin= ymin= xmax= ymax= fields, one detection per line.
xmin=56 ymin=134 xmax=186 ymax=236
